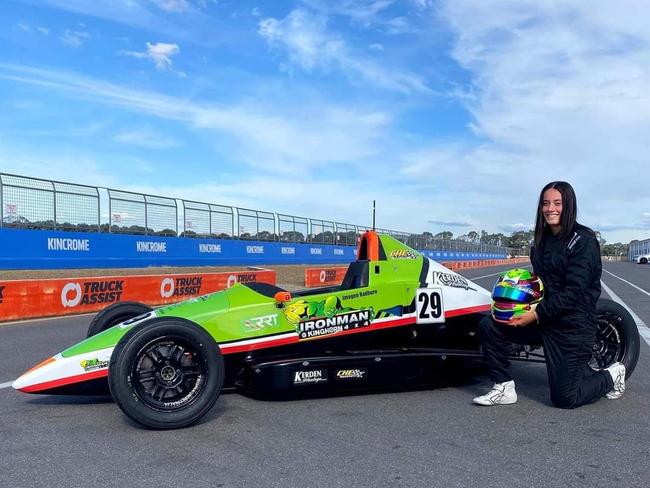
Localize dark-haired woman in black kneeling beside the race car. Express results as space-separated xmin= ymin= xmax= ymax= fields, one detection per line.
xmin=473 ymin=181 xmax=625 ymax=408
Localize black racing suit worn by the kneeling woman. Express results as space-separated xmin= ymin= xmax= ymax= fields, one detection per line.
xmin=480 ymin=224 xmax=613 ymax=408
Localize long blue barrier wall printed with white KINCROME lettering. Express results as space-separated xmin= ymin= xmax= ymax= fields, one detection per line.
xmin=0 ymin=228 xmax=505 ymax=269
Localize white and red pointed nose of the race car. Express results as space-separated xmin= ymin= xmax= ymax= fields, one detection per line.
xmin=11 ymin=347 xmax=113 ymax=393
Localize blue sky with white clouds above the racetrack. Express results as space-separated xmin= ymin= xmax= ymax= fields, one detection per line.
xmin=0 ymin=0 xmax=650 ymax=242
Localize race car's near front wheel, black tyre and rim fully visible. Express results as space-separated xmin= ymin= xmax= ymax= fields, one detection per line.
xmin=108 ymin=317 xmax=224 ymax=429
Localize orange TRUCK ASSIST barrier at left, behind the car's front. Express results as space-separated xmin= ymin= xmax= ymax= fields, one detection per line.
xmin=0 ymin=270 xmax=276 ymax=321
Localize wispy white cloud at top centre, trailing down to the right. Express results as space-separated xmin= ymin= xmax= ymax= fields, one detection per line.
xmin=258 ymin=9 xmax=430 ymax=94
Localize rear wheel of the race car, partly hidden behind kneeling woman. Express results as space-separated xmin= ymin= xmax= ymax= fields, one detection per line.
xmin=590 ymin=299 xmax=641 ymax=378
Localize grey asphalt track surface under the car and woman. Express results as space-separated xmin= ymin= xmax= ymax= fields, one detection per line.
xmin=0 ymin=262 xmax=650 ymax=488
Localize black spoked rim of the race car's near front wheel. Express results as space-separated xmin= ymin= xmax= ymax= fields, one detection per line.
xmin=131 ymin=336 xmax=207 ymax=412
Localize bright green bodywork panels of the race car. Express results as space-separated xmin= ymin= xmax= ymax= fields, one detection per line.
xmin=61 ymin=235 xmax=425 ymax=358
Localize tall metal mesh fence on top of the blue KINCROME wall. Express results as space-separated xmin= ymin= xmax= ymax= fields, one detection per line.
xmin=0 ymin=173 xmax=507 ymax=255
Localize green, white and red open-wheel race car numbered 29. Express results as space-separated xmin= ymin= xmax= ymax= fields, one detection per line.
xmin=13 ymin=231 xmax=639 ymax=429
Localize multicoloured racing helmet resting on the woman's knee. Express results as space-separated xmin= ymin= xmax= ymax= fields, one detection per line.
xmin=492 ymin=268 xmax=544 ymax=322
